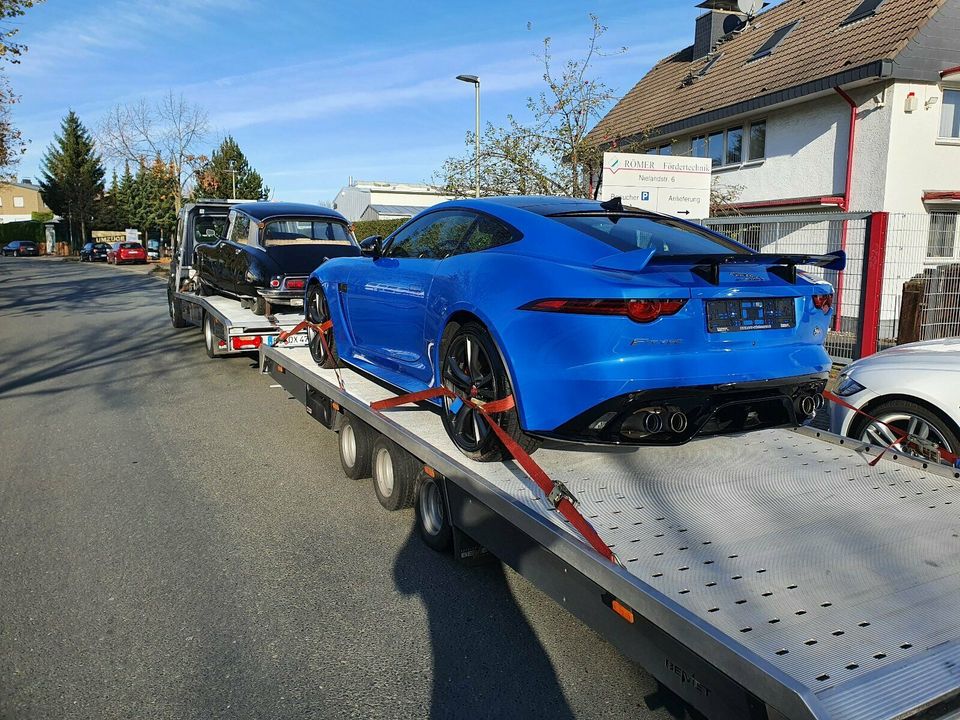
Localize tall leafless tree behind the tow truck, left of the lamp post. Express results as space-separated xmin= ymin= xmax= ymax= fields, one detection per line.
xmin=98 ymin=91 xmax=209 ymax=212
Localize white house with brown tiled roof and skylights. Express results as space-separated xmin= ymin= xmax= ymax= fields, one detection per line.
xmin=590 ymin=0 xmax=960 ymax=219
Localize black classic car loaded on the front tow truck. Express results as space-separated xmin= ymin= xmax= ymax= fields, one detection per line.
xmin=193 ymin=202 xmax=360 ymax=315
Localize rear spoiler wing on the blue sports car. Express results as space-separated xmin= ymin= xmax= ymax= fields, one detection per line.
xmin=593 ymin=248 xmax=847 ymax=285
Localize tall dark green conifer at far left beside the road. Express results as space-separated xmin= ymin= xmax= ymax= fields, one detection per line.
xmin=40 ymin=110 xmax=104 ymax=250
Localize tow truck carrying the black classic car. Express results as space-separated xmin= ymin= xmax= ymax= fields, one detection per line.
xmin=167 ymin=199 xmax=307 ymax=358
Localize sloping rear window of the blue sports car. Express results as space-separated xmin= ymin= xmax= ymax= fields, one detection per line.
xmin=550 ymin=214 xmax=751 ymax=255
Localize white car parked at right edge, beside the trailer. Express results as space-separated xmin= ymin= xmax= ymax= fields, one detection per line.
xmin=830 ymin=338 xmax=960 ymax=462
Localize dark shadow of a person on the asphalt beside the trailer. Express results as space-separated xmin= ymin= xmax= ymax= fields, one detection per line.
xmin=393 ymin=529 xmax=573 ymax=720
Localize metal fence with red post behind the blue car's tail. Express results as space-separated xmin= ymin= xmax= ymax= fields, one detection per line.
xmin=704 ymin=213 xmax=960 ymax=362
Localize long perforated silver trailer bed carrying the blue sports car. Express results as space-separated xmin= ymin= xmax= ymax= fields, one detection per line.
xmin=260 ymin=346 xmax=960 ymax=720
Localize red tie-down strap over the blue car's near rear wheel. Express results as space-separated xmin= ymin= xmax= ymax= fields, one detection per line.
xmin=370 ymin=387 xmax=621 ymax=565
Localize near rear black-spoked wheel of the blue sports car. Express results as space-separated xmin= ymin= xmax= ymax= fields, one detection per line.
xmin=440 ymin=322 xmax=537 ymax=462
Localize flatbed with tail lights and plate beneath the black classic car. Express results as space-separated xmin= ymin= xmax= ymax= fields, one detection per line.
xmin=174 ymin=292 xmax=307 ymax=357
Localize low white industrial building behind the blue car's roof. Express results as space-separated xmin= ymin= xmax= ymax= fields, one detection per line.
xmin=333 ymin=178 xmax=453 ymax=222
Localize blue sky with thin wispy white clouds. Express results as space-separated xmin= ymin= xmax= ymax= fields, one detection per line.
xmin=9 ymin=0 xmax=752 ymax=202
